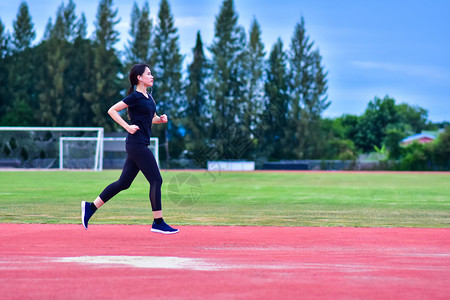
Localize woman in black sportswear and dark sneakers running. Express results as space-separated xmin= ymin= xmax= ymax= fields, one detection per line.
xmin=81 ymin=64 xmax=178 ymax=234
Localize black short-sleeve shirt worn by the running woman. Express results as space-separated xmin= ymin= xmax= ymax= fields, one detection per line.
xmin=123 ymin=91 xmax=156 ymax=145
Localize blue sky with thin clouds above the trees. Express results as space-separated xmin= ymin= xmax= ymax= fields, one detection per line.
xmin=0 ymin=0 xmax=450 ymax=122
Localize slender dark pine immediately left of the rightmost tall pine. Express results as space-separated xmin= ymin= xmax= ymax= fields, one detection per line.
xmin=259 ymin=38 xmax=290 ymax=160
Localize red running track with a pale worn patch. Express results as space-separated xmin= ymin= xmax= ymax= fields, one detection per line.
xmin=0 ymin=224 xmax=450 ymax=299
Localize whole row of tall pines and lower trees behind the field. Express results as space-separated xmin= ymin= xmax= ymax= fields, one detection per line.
xmin=0 ymin=0 xmax=450 ymax=168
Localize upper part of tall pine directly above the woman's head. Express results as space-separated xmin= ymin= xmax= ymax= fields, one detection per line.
xmin=125 ymin=2 xmax=152 ymax=67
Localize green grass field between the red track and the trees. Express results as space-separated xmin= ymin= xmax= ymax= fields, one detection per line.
xmin=0 ymin=170 xmax=450 ymax=227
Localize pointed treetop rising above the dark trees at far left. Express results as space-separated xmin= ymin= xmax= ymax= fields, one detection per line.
xmin=12 ymin=1 xmax=36 ymax=52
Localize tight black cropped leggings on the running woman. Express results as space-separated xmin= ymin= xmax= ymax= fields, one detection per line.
xmin=99 ymin=144 xmax=162 ymax=211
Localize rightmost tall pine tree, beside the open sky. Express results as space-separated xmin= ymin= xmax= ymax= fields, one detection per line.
xmin=287 ymin=18 xmax=330 ymax=158
